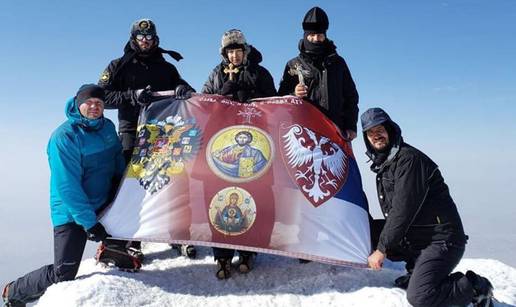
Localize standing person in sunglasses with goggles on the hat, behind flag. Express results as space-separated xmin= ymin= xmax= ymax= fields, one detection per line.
xmin=98 ymin=18 xmax=196 ymax=268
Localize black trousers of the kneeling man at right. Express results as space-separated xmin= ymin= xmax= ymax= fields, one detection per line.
xmin=371 ymin=220 xmax=473 ymax=307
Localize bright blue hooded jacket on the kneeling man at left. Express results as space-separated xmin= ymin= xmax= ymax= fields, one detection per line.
xmin=47 ymin=98 xmax=125 ymax=229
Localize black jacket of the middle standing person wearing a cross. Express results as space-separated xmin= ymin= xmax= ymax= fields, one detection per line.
xmin=202 ymin=46 xmax=277 ymax=102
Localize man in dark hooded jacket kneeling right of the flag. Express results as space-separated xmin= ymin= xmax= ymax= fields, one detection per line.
xmin=361 ymin=108 xmax=493 ymax=306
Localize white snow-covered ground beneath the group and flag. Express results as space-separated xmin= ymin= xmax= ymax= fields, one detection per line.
xmin=37 ymin=244 xmax=516 ymax=307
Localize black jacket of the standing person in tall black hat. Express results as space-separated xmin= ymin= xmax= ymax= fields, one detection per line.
xmin=278 ymin=40 xmax=358 ymax=132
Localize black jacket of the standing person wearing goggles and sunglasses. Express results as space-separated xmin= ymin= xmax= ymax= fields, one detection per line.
xmin=98 ymin=43 xmax=191 ymax=133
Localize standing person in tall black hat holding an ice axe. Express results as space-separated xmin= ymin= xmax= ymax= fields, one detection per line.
xmin=278 ymin=7 xmax=358 ymax=140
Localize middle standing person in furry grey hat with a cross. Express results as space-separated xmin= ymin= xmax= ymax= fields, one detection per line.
xmin=202 ymin=29 xmax=277 ymax=279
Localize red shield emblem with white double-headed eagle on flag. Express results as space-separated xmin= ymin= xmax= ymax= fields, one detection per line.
xmin=280 ymin=125 xmax=351 ymax=207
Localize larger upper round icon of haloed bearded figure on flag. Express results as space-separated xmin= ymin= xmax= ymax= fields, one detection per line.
xmin=206 ymin=125 xmax=274 ymax=183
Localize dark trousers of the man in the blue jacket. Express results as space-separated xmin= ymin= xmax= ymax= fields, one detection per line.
xmin=9 ymin=223 xmax=86 ymax=303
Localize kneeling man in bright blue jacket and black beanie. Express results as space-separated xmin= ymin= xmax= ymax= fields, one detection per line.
xmin=2 ymin=84 xmax=125 ymax=306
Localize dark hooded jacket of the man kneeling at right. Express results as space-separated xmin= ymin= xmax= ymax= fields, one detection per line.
xmin=361 ymin=108 xmax=467 ymax=255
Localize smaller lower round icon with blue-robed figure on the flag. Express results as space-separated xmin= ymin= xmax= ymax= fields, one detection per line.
xmin=208 ymin=187 xmax=256 ymax=236
